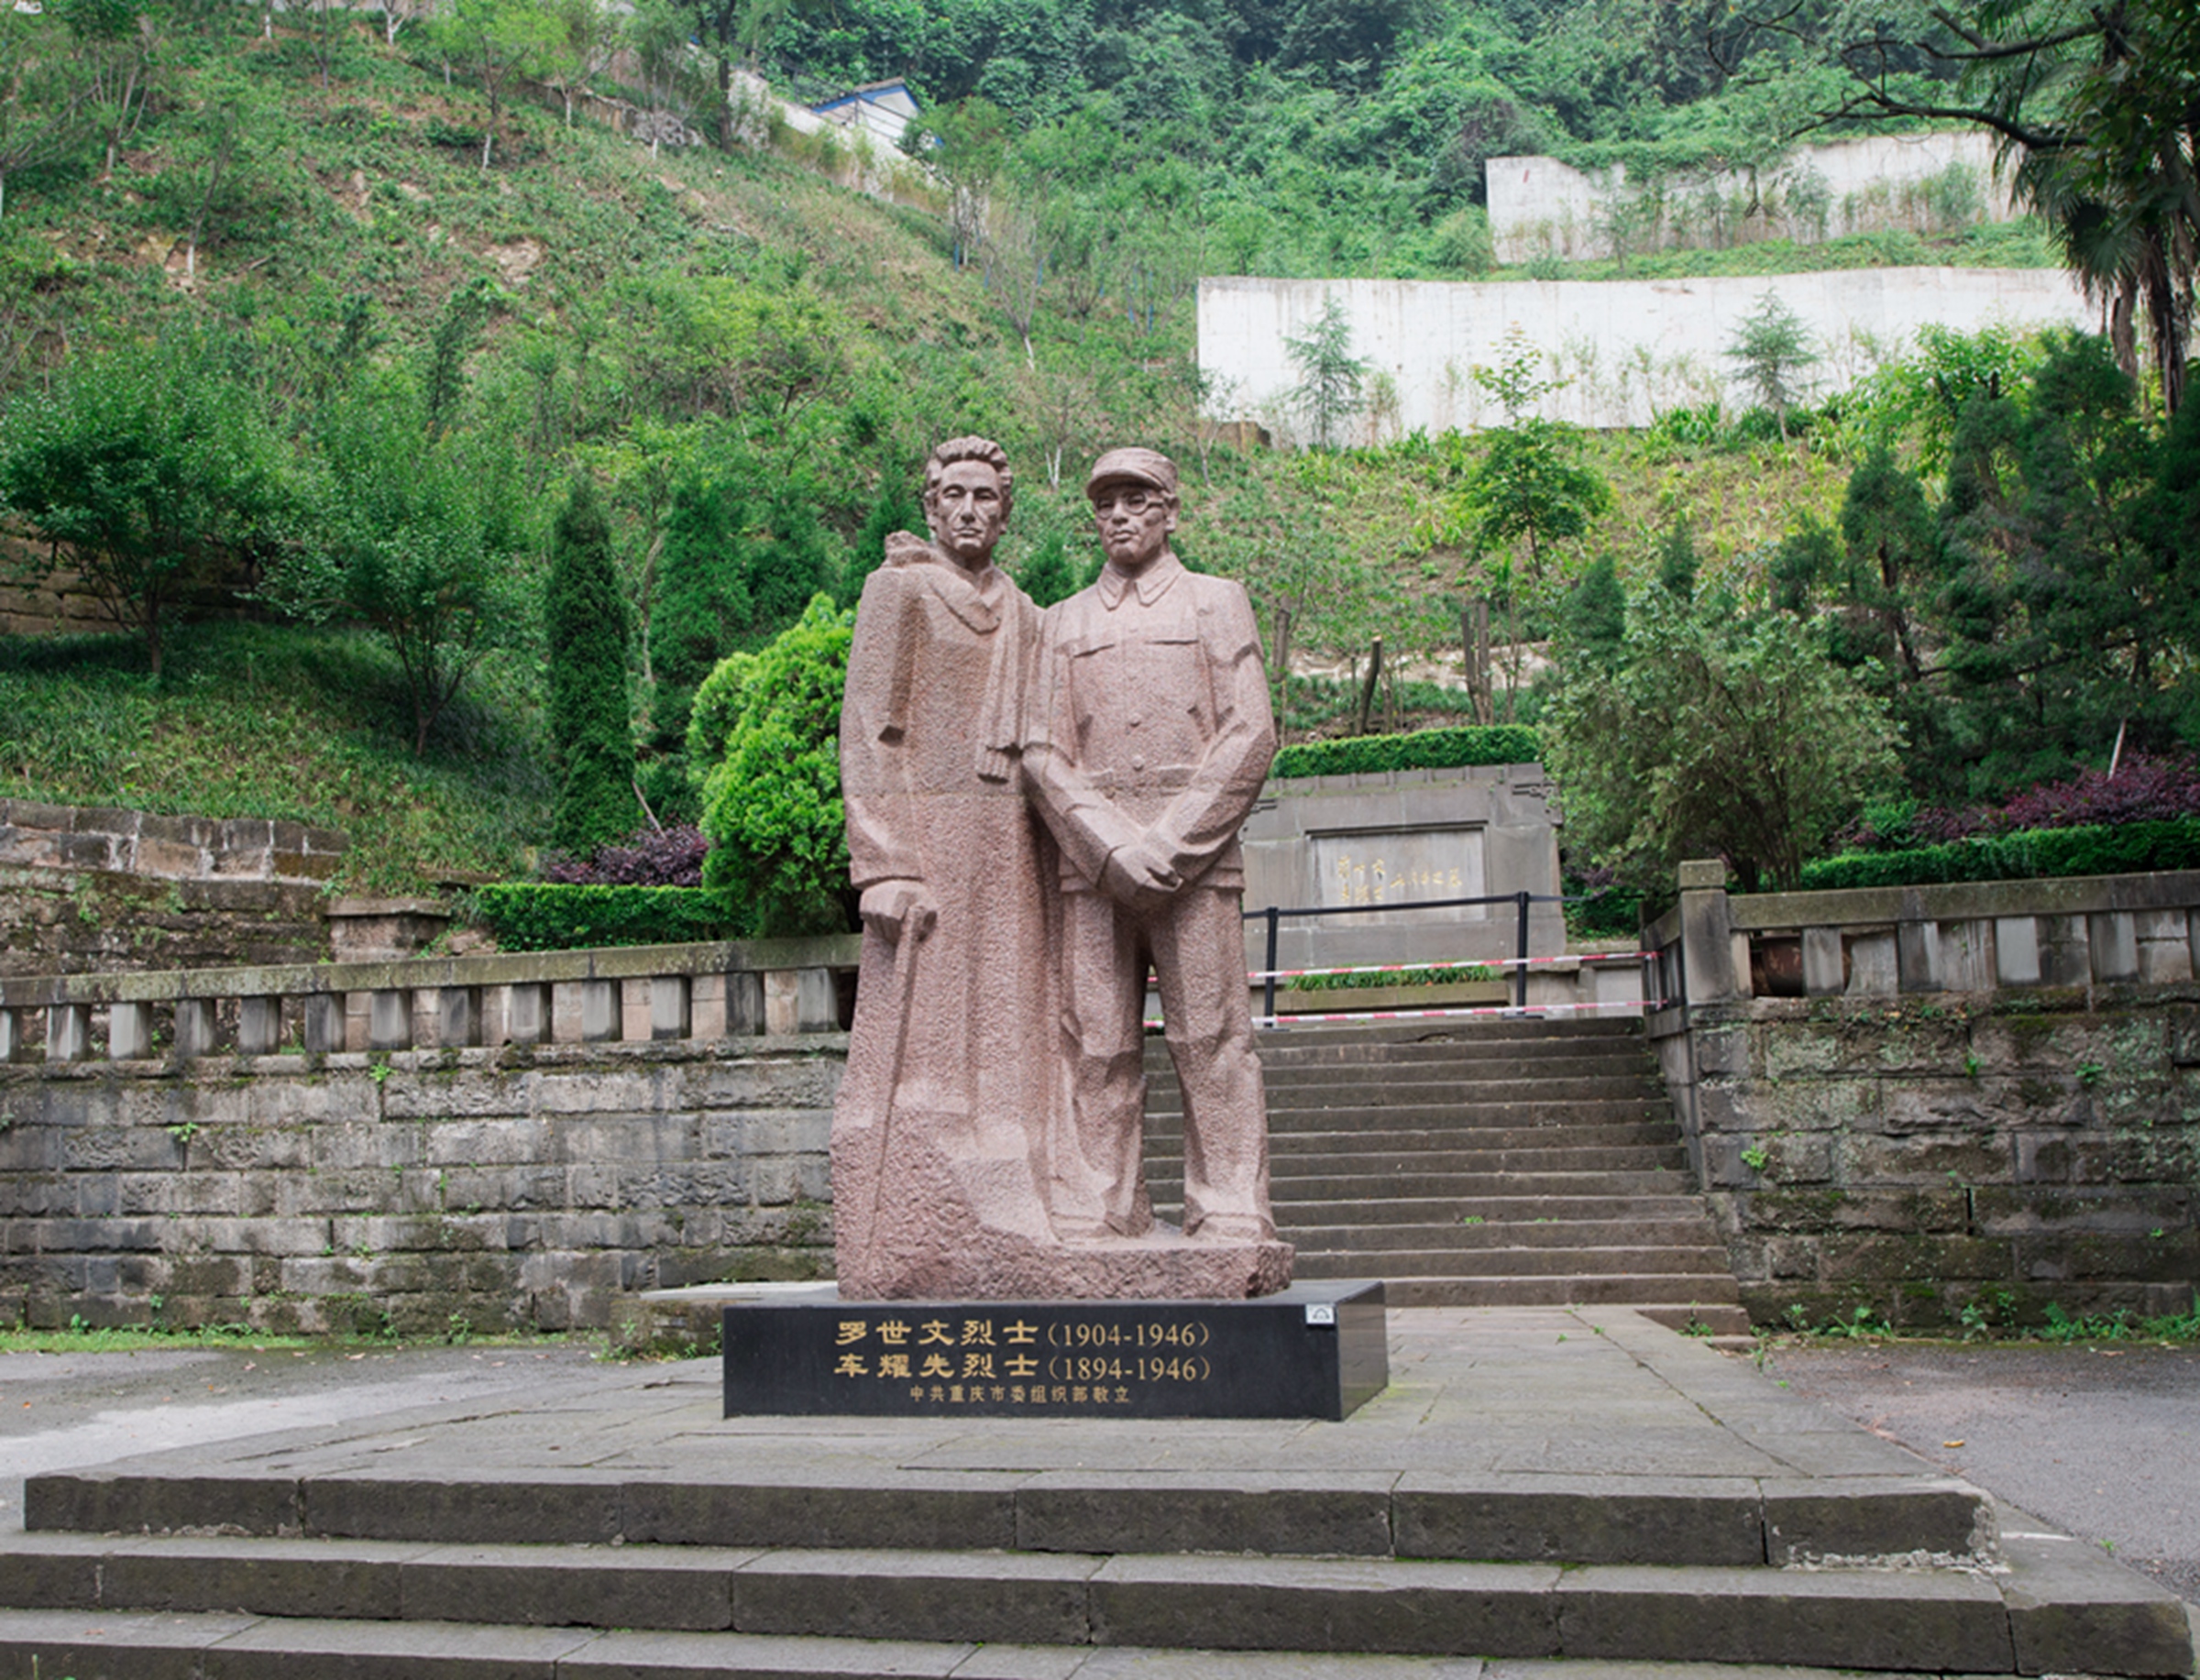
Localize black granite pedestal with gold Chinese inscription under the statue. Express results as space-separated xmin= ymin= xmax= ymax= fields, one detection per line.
xmin=726 ymin=1282 xmax=1391 ymax=1421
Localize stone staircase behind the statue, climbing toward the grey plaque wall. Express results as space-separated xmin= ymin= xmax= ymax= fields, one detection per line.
xmin=1146 ymin=1020 xmax=1749 ymax=1334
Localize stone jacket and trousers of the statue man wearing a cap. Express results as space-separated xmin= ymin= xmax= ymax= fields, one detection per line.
xmin=1025 ymin=550 xmax=1276 ymax=1235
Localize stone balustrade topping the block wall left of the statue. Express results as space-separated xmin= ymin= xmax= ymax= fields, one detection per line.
xmin=0 ymin=937 xmax=860 ymax=1062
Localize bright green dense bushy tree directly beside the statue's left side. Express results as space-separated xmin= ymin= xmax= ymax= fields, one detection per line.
xmin=688 ymin=596 xmax=856 ymax=939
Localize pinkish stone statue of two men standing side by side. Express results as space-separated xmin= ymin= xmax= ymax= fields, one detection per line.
xmin=831 ymin=437 xmax=1292 ymax=1300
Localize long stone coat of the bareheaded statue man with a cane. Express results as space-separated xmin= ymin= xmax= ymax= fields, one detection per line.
xmin=831 ymin=539 xmax=1054 ymax=1298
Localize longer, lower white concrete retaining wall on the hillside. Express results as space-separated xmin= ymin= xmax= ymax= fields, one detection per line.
xmin=1199 ymin=269 xmax=2099 ymax=433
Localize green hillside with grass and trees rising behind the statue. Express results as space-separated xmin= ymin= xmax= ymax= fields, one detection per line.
xmin=0 ymin=0 xmax=2164 ymax=906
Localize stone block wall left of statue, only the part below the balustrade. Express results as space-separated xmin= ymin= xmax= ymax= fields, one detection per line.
xmin=0 ymin=1034 xmax=845 ymax=1334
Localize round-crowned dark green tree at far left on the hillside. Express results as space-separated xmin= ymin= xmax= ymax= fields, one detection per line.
xmin=0 ymin=332 xmax=297 ymax=677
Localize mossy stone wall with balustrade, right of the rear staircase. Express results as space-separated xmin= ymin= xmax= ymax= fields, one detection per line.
xmin=1650 ymin=864 xmax=2200 ymax=1326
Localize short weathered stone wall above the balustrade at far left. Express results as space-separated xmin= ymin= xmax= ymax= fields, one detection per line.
xmin=0 ymin=798 xmax=347 ymax=976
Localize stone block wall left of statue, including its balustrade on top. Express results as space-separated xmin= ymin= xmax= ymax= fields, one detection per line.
xmin=0 ymin=939 xmax=860 ymax=1333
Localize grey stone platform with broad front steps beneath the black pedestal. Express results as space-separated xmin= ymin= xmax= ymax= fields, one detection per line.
xmin=0 ymin=1309 xmax=2194 ymax=1680
